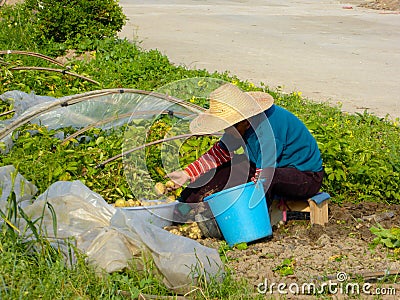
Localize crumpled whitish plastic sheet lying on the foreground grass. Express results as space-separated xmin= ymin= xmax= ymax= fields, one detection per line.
xmin=0 ymin=167 xmax=223 ymax=291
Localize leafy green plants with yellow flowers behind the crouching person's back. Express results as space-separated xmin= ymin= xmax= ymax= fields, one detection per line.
xmin=274 ymin=93 xmax=400 ymax=203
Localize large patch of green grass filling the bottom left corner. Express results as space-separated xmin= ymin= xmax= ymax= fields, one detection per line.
xmin=0 ymin=236 xmax=177 ymax=299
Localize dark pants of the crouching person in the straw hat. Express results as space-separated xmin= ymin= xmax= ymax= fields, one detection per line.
xmin=180 ymin=155 xmax=324 ymax=204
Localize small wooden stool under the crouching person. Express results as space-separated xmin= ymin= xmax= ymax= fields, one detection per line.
xmin=270 ymin=192 xmax=330 ymax=225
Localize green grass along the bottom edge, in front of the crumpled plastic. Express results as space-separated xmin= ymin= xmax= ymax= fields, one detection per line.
xmin=0 ymin=234 xmax=262 ymax=299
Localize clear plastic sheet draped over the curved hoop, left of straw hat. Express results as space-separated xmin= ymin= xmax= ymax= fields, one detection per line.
xmin=0 ymin=89 xmax=199 ymax=133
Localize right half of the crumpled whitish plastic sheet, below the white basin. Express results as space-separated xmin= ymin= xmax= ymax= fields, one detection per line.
xmin=111 ymin=210 xmax=223 ymax=290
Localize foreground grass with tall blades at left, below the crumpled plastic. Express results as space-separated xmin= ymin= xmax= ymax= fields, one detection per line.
xmin=0 ymin=184 xmax=262 ymax=299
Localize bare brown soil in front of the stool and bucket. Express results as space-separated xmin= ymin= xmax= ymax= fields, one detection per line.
xmin=193 ymin=203 xmax=400 ymax=292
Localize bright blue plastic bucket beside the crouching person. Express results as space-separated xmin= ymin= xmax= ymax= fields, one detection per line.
xmin=204 ymin=181 xmax=272 ymax=246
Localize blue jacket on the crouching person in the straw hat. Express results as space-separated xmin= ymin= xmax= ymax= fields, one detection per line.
xmin=221 ymin=104 xmax=323 ymax=172
